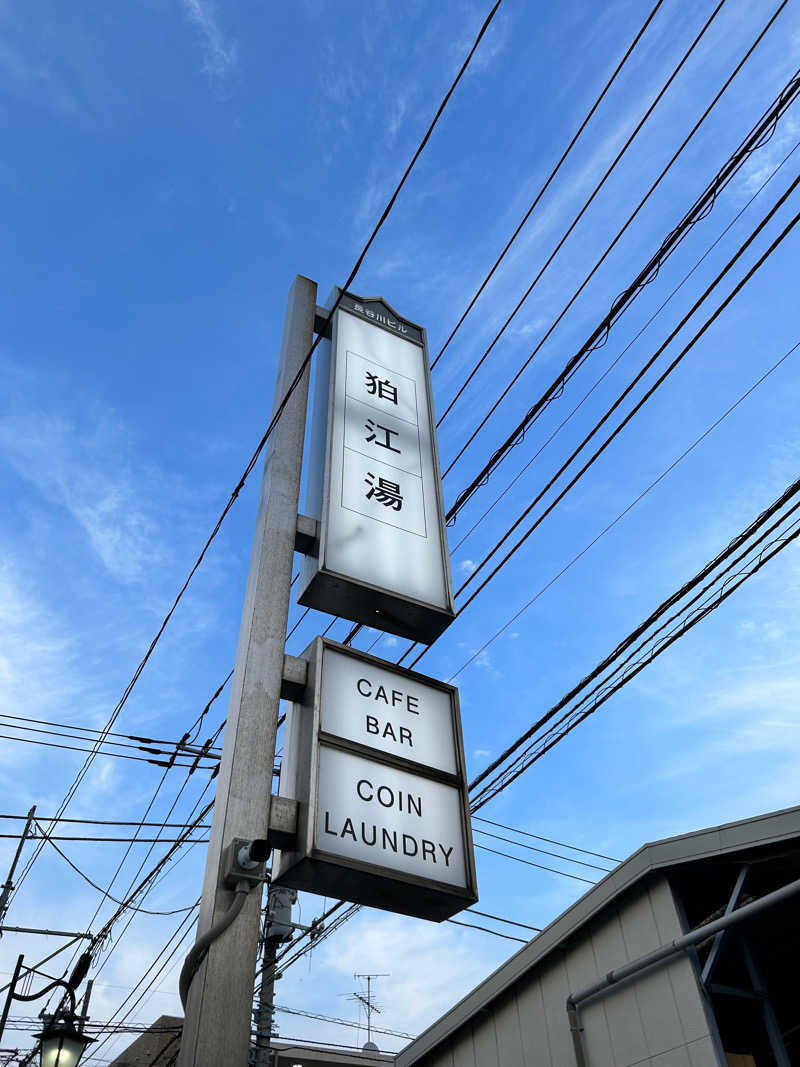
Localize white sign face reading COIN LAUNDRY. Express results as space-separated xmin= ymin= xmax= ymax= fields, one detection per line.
xmin=315 ymin=744 xmax=467 ymax=888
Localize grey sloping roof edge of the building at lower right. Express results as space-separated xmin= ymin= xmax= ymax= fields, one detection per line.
xmin=396 ymin=807 xmax=800 ymax=1067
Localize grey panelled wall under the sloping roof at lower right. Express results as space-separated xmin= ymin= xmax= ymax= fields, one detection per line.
xmin=409 ymin=877 xmax=722 ymax=1067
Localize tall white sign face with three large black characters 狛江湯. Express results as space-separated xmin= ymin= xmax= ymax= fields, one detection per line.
xmin=322 ymin=308 xmax=451 ymax=609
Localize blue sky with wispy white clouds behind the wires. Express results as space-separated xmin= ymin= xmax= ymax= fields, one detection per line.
xmin=0 ymin=0 xmax=800 ymax=1062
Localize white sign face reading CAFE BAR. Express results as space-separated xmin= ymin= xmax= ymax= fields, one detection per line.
xmin=320 ymin=648 xmax=458 ymax=775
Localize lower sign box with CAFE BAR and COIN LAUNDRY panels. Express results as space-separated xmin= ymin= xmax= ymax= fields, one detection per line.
xmin=272 ymin=637 xmax=478 ymax=922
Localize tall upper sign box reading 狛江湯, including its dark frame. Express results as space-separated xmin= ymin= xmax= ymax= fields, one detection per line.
xmin=298 ymin=293 xmax=454 ymax=643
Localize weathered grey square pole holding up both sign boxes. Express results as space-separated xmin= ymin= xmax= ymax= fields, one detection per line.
xmin=178 ymin=275 xmax=317 ymax=1067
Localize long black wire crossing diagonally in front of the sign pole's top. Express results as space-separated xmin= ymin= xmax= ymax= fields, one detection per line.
xmin=9 ymin=0 xmax=503 ymax=909
